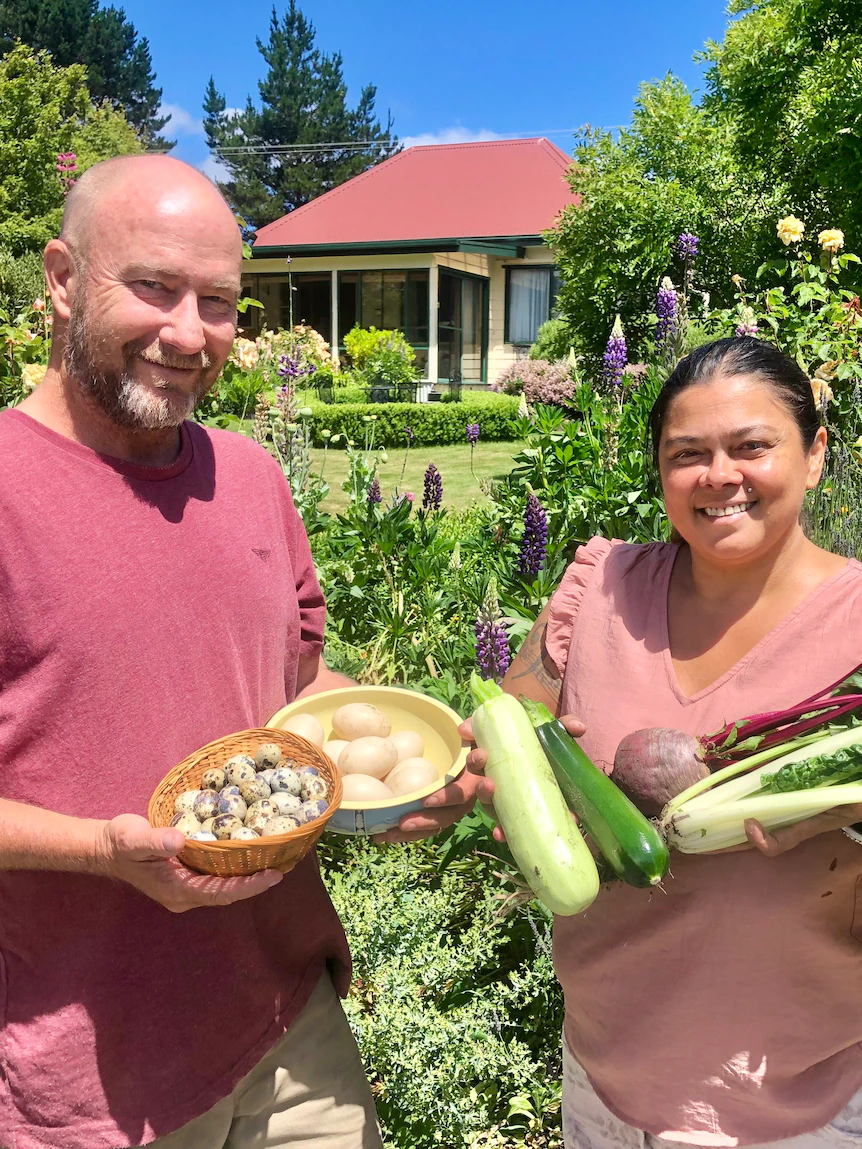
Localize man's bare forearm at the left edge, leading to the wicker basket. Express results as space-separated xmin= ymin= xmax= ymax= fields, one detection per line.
xmin=0 ymin=799 xmax=108 ymax=874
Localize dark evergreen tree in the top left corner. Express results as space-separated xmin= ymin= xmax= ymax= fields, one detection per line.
xmin=0 ymin=0 xmax=172 ymax=148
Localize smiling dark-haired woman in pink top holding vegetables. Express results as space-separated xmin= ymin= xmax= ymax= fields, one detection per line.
xmin=388 ymin=338 xmax=862 ymax=1149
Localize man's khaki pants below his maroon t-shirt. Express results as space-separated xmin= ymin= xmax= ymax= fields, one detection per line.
xmin=147 ymin=973 xmax=383 ymax=1149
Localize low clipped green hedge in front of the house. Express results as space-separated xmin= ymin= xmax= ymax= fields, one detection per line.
xmin=308 ymin=392 xmax=518 ymax=447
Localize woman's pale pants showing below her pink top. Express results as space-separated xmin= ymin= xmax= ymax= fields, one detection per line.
xmin=563 ymin=1038 xmax=862 ymax=1149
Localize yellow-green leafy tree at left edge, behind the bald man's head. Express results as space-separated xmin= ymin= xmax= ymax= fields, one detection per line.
xmin=0 ymin=45 xmax=141 ymax=255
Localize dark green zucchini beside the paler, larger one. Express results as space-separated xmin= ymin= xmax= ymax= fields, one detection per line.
xmin=521 ymin=697 xmax=670 ymax=888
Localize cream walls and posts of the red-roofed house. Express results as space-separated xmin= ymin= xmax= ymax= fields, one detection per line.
xmin=248 ymin=245 xmax=554 ymax=387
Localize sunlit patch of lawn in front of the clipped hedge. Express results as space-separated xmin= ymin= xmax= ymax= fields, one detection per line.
xmin=311 ymin=442 xmax=521 ymax=512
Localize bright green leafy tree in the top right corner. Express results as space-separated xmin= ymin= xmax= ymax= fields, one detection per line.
xmin=705 ymin=0 xmax=862 ymax=250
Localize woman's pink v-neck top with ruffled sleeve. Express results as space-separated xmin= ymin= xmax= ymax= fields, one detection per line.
xmin=547 ymin=539 xmax=862 ymax=1146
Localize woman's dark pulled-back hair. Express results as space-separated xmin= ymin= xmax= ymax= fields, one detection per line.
xmin=649 ymin=336 xmax=821 ymax=464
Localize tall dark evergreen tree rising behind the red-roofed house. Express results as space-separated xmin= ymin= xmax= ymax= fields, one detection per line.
xmin=203 ymin=0 xmax=398 ymax=228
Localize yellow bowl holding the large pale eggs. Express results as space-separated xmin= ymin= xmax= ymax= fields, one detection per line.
xmin=267 ymin=686 xmax=468 ymax=835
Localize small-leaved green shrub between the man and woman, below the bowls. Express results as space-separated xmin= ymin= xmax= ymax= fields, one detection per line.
xmin=322 ymin=836 xmax=563 ymax=1149
